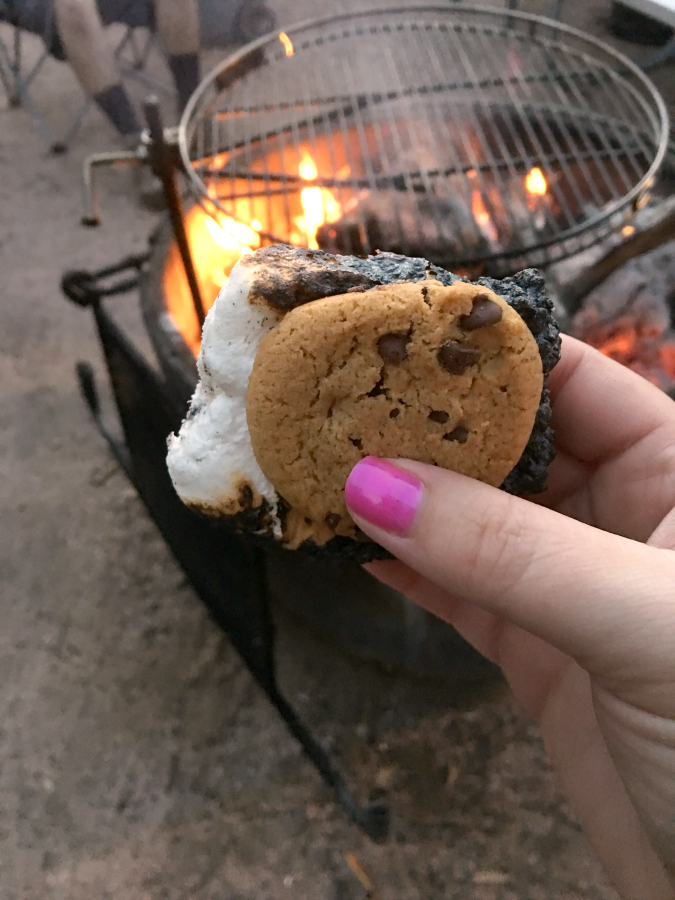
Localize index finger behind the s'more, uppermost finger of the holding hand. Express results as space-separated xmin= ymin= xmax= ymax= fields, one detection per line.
xmin=549 ymin=336 xmax=675 ymax=463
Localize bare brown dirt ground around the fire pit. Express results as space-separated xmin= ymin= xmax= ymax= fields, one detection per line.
xmin=0 ymin=0 xmax=675 ymax=900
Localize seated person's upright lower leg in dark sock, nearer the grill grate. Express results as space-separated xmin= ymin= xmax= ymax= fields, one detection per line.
xmin=154 ymin=0 xmax=201 ymax=112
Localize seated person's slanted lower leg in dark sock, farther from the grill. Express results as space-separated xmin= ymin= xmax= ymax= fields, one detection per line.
xmin=54 ymin=0 xmax=141 ymax=135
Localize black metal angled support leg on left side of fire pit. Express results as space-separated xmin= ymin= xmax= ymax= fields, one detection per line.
xmin=64 ymin=273 xmax=389 ymax=840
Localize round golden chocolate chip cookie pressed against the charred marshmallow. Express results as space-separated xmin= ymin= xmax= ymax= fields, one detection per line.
xmin=246 ymin=280 xmax=543 ymax=539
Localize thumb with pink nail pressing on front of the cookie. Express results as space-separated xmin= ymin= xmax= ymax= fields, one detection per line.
xmin=345 ymin=457 xmax=675 ymax=675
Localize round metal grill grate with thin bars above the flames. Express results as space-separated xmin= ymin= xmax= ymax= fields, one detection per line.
xmin=180 ymin=6 xmax=668 ymax=274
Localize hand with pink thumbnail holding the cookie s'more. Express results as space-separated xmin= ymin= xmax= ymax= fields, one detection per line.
xmin=346 ymin=338 xmax=675 ymax=900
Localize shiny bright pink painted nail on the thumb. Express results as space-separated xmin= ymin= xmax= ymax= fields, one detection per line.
xmin=345 ymin=456 xmax=422 ymax=537
